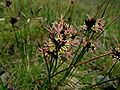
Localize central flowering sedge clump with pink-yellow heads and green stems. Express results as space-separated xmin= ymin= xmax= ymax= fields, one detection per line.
xmin=39 ymin=1 xmax=119 ymax=89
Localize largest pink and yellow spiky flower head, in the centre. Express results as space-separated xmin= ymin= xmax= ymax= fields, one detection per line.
xmin=41 ymin=17 xmax=79 ymax=56
